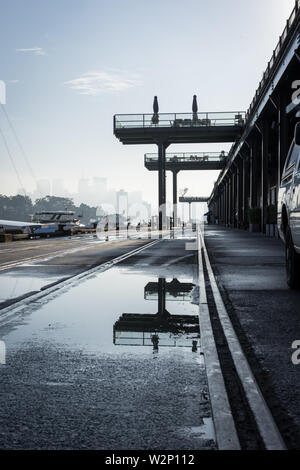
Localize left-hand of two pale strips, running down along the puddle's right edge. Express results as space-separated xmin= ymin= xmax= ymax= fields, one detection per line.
xmin=198 ymin=229 xmax=241 ymax=450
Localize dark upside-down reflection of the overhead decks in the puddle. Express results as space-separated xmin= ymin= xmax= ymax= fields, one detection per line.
xmin=113 ymin=278 xmax=200 ymax=351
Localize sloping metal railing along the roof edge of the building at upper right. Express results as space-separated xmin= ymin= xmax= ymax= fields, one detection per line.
xmin=246 ymin=0 xmax=300 ymax=122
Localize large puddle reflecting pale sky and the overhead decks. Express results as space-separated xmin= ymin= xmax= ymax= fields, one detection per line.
xmin=4 ymin=268 xmax=199 ymax=356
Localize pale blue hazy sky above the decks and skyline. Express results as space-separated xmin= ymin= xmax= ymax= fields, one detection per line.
xmin=0 ymin=0 xmax=295 ymax=204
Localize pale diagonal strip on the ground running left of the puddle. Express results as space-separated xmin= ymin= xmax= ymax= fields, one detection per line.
xmin=0 ymin=240 xmax=160 ymax=327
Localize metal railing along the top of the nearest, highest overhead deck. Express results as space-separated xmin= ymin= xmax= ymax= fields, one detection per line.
xmin=114 ymin=111 xmax=246 ymax=130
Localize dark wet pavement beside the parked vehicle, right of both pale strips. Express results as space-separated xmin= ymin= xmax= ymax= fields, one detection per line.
xmin=205 ymin=226 xmax=300 ymax=449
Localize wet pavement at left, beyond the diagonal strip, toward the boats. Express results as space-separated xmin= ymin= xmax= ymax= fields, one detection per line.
xmin=0 ymin=234 xmax=162 ymax=310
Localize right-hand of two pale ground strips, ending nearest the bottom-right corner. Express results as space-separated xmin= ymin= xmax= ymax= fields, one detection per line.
xmin=199 ymin=231 xmax=286 ymax=450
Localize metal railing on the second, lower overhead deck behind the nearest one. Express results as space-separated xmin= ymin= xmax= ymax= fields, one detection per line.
xmin=145 ymin=151 xmax=228 ymax=163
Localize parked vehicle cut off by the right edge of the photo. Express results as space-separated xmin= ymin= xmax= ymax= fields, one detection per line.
xmin=277 ymin=122 xmax=300 ymax=288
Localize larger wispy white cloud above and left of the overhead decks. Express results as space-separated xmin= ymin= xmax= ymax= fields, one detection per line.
xmin=64 ymin=72 xmax=140 ymax=95
